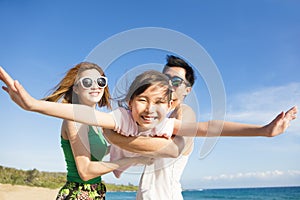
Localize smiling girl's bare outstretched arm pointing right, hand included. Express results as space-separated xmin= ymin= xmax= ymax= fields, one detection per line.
xmin=174 ymin=106 xmax=298 ymax=137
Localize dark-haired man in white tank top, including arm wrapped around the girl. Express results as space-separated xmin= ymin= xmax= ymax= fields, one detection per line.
xmin=104 ymin=55 xmax=196 ymax=200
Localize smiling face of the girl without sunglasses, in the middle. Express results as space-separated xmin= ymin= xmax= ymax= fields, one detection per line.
xmin=129 ymin=85 xmax=170 ymax=131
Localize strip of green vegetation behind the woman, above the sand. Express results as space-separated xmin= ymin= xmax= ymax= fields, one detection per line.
xmin=0 ymin=166 xmax=138 ymax=191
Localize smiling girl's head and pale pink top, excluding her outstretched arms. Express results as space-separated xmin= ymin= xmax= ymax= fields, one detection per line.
xmin=106 ymin=70 xmax=174 ymax=178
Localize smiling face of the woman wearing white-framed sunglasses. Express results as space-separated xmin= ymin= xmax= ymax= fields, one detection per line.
xmin=73 ymin=69 xmax=104 ymax=107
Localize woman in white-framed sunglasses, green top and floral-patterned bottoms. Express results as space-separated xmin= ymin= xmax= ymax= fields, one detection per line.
xmin=1 ymin=62 xmax=149 ymax=200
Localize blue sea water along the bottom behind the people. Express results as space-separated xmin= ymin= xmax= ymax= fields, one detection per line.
xmin=107 ymin=187 xmax=300 ymax=200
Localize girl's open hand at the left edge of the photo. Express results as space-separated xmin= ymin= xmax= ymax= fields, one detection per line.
xmin=0 ymin=67 xmax=37 ymax=110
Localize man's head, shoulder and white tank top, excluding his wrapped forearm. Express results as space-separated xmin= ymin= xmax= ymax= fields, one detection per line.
xmin=137 ymin=55 xmax=196 ymax=200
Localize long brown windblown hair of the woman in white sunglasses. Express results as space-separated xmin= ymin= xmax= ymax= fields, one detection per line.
xmin=43 ymin=62 xmax=111 ymax=109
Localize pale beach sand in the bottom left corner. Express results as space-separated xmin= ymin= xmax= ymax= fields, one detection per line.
xmin=0 ymin=184 xmax=59 ymax=200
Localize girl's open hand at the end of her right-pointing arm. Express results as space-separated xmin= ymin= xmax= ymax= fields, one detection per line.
xmin=264 ymin=106 xmax=298 ymax=137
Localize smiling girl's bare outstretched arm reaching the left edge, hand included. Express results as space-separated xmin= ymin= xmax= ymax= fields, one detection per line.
xmin=0 ymin=67 xmax=115 ymax=129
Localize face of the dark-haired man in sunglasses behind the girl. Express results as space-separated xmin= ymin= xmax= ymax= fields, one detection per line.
xmin=164 ymin=67 xmax=191 ymax=107
